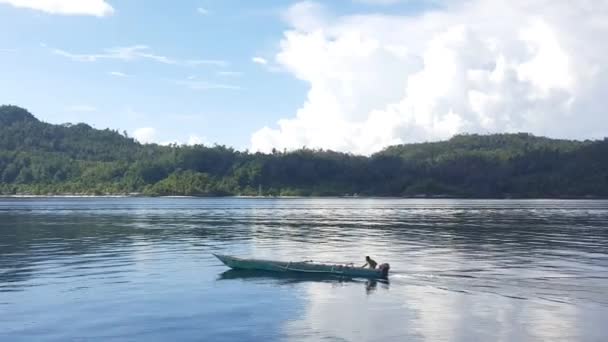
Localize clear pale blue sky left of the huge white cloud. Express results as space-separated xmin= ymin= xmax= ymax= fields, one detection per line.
xmin=0 ymin=0 xmax=420 ymax=148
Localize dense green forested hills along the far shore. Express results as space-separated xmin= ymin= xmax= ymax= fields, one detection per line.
xmin=0 ymin=106 xmax=608 ymax=198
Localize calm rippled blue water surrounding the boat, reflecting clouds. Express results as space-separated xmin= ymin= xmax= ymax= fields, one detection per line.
xmin=0 ymin=198 xmax=608 ymax=341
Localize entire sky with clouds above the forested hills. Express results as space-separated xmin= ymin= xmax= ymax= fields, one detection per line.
xmin=0 ymin=0 xmax=608 ymax=154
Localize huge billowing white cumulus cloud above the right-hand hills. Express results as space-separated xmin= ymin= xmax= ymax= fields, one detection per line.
xmin=251 ymin=0 xmax=608 ymax=154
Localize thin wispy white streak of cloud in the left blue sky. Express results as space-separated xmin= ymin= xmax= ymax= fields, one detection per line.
xmin=52 ymin=45 xmax=228 ymax=67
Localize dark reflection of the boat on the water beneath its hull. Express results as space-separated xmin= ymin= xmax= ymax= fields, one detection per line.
xmin=217 ymin=270 xmax=390 ymax=294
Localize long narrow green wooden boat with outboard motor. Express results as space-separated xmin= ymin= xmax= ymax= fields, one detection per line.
xmin=213 ymin=254 xmax=390 ymax=279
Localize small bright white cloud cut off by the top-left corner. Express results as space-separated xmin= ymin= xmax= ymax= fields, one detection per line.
xmin=0 ymin=0 xmax=114 ymax=17
